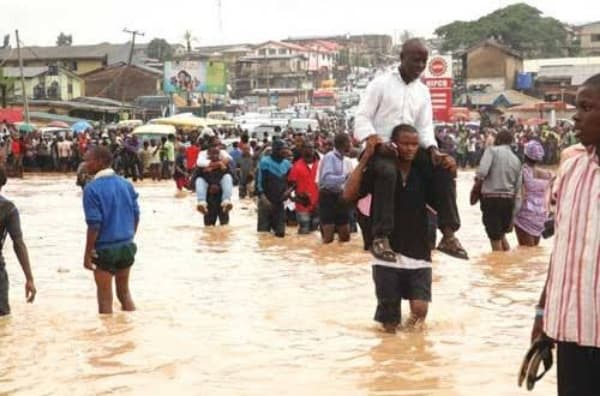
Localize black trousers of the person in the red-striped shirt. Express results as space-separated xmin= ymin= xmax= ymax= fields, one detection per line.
xmin=556 ymin=342 xmax=600 ymax=396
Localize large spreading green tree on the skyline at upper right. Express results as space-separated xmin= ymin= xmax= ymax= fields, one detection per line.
xmin=435 ymin=3 xmax=571 ymax=57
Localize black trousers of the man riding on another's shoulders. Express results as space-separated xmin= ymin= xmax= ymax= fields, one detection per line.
xmin=370 ymin=148 xmax=460 ymax=238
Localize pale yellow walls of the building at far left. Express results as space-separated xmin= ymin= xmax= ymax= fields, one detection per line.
xmin=2 ymin=66 xmax=85 ymax=100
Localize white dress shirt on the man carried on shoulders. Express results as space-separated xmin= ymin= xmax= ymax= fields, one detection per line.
xmin=354 ymin=69 xmax=437 ymax=148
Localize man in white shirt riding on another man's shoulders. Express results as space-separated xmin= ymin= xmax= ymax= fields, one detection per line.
xmin=355 ymin=39 xmax=468 ymax=262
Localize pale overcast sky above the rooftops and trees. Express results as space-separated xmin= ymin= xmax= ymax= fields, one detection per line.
xmin=0 ymin=0 xmax=600 ymax=46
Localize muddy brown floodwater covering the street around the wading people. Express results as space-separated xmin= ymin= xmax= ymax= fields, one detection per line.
xmin=0 ymin=172 xmax=556 ymax=395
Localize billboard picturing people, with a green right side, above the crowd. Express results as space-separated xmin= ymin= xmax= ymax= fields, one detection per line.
xmin=163 ymin=61 xmax=227 ymax=94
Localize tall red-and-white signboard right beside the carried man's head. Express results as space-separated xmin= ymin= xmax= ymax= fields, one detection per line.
xmin=423 ymin=55 xmax=453 ymax=122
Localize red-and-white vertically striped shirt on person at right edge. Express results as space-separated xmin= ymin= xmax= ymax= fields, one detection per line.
xmin=544 ymin=148 xmax=600 ymax=347
